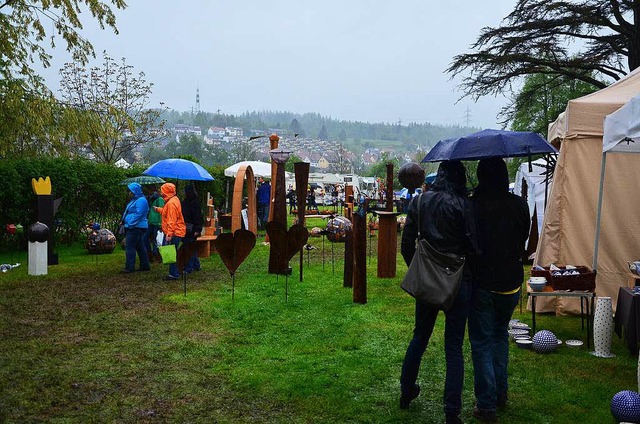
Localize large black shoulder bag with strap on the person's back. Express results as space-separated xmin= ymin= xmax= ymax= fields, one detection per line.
xmin=400 ymin=194 xmax=465 ymax=311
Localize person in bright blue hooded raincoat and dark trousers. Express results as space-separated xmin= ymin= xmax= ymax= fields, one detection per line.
xmin=122 ymin=183 xmax=151 ymax=273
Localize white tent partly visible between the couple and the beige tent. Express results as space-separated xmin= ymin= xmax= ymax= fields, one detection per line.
xmin=513 ymin=158 xmax=551 ymax=249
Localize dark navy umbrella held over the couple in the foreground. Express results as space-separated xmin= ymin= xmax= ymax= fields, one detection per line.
xmin=422 ymin=130 xmax=558 ymax=162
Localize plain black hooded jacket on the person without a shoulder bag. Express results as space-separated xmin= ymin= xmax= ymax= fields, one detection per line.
xmin=472 ymin=158 xmax=531 ymax=292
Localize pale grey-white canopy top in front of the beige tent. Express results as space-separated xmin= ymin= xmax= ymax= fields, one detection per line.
xmin=602 ymin=95 xmax=640 ymax=153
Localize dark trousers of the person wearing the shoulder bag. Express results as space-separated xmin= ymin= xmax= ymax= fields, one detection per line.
xmin=400 ymin=281 xmax=471 ymax=415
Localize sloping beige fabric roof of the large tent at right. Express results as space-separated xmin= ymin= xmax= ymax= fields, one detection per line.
xmin=547 ymin=68 xmax=640 ymax=144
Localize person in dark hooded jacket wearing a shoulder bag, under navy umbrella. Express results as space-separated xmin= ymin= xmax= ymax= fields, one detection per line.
xmin=400 ymin=161 xmax=476 ymax=423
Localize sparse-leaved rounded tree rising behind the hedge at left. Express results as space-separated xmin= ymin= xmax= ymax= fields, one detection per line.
xmin=60 ymin=52 xmax=164 ymax=163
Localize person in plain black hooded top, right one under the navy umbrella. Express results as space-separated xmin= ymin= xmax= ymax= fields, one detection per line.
xmin=469 ymin=158 xmax=531 ymax=422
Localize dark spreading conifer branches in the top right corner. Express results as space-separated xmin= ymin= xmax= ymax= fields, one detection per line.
xmin=447 ymin=0 xmax=640 ymax=99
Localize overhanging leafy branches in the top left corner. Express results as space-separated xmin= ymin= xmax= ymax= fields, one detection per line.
xmin=0 ymin=0 xmax=127 ymax=80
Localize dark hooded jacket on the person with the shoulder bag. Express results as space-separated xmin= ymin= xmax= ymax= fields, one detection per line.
xmin=400 ymin=161 xmax=477 ymax=281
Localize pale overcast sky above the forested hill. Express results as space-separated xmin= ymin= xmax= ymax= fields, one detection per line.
xmin=37 ymin=0 xmax=516 ymax=128
